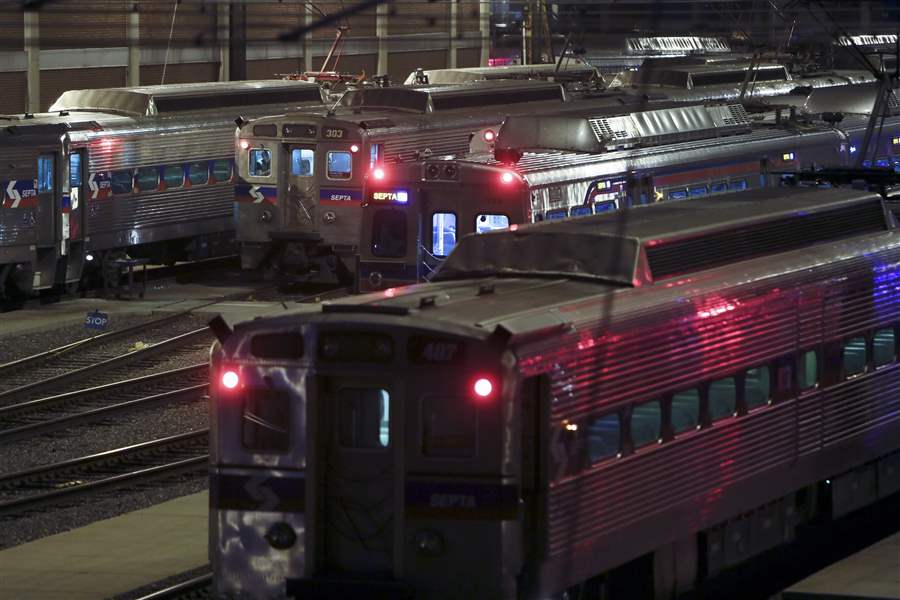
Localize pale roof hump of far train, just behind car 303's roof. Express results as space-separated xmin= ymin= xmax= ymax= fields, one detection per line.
xmin=404 ymin=59 xmax=602 ymax=85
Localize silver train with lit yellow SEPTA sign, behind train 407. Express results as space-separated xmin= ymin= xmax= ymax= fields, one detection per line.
xmin=357 ymin=104 xmax=884 ymax=291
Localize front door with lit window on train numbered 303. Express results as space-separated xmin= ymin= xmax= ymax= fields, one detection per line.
xmin=282 ymin=144 xmax=319 ymax=233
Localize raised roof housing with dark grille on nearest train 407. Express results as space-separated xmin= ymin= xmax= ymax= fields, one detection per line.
xmin=432 ymin=189 xmax=892 ymax=287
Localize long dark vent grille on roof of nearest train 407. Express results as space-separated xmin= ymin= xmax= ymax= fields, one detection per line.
xmin=645 ymin=201 xmax=887 ymax=280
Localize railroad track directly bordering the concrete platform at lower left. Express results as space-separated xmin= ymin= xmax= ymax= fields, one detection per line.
xmin=0 ymin=429 xmax=209 ymax=519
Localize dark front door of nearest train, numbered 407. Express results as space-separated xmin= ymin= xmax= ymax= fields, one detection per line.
xmin=317 ymin=377 xmax=403 ymax=579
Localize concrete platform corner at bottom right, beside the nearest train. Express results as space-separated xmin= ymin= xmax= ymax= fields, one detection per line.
xmin=782 ymin=533 xmax=900 ymax=600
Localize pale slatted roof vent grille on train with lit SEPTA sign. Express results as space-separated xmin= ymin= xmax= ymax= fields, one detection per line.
xmin=589 ymin=104 xmax=750 ymax=150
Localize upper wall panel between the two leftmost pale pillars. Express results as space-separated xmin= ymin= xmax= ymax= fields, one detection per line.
xmin=40 ymin=0 xmax=129 ymax=49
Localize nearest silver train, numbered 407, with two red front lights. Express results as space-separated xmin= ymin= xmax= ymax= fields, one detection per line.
xmin=210 ymin=189 xmax=900 ymax=600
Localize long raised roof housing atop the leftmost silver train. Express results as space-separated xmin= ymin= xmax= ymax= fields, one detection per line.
xmin=50 ymin=79 xmax=325 ymax=117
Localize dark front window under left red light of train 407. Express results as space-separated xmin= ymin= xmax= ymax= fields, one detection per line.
xmin=241 ymin=388 xmax=291 ymax=453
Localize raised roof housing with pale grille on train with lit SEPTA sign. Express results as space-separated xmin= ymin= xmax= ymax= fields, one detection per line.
xmin=494 ymin=103 xmax=751 ymax=153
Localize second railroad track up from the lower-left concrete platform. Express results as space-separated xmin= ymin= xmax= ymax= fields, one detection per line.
xmin=0 ymin=363 xmax=209 ymax=444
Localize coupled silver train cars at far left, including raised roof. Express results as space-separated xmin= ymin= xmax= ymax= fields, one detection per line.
xmin=0 ymin=80 xmax=324 ymax=297
